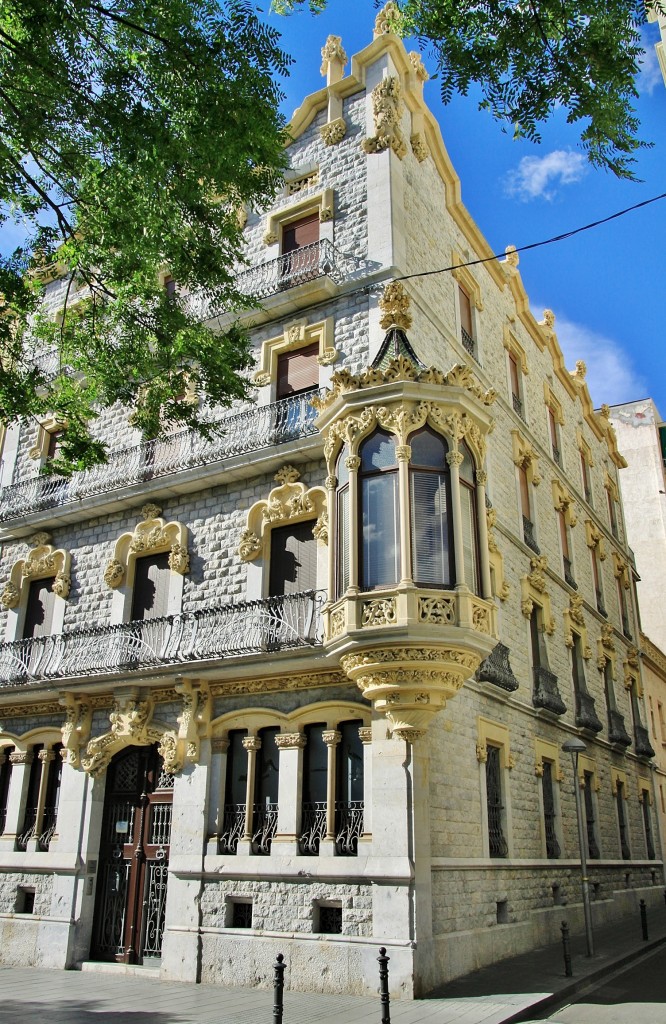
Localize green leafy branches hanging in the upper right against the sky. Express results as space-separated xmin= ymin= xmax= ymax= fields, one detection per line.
xmin=274 ymin=0 xmax=666 ymax=177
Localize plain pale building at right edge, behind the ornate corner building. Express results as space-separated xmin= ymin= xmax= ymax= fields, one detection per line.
xmin=611 ymin=398 xmax=666 ymax=650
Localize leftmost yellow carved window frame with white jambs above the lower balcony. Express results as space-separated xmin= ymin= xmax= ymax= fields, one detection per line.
xmin=0 ymin=531 xmax=72 ymax=643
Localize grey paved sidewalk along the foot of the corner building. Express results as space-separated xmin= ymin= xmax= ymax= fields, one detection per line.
xmin=0 ymin=907 xmax=666 ymax=1024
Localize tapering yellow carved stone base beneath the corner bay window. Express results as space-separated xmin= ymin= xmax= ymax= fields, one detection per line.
xmin=341 ymin=646 xmax=490 ymax=742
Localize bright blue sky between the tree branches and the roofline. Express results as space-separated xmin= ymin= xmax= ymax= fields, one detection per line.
xmin=268 ymin=0 xmax=666 ymax=417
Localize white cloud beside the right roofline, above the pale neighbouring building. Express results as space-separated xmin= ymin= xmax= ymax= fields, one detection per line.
xmin=533 ymin=306 xmax=650 ymax=409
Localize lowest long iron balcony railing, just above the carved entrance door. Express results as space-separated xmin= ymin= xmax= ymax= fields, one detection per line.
xmin=0 ymin=591 xmax=325 ymax=686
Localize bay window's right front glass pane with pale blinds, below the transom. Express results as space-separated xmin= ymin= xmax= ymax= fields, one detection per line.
xmin=411 ymin=470 xmax=453 ymax=587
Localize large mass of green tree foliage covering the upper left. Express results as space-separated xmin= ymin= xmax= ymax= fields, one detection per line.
xmin=0 ymin=0 xmax=288 ymax=469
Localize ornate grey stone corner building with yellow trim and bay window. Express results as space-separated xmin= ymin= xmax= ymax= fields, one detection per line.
xmin=0 ymin=13 xmax=664 ymax=997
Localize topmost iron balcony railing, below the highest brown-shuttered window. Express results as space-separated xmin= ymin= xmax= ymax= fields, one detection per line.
xmin=185 ymin=239 xmax=363 ymax=319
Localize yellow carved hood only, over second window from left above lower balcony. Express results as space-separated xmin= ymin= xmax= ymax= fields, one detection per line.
xmin=103 ymin=505 xmax=190 ymax=590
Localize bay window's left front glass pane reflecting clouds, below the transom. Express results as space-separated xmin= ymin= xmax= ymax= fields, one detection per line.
xmin=361 ymin=472 xmax=399 ymax=590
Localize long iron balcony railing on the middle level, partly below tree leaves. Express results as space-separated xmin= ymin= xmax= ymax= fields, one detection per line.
xmin=0 ymin=391 xmax=317 ymax=522
